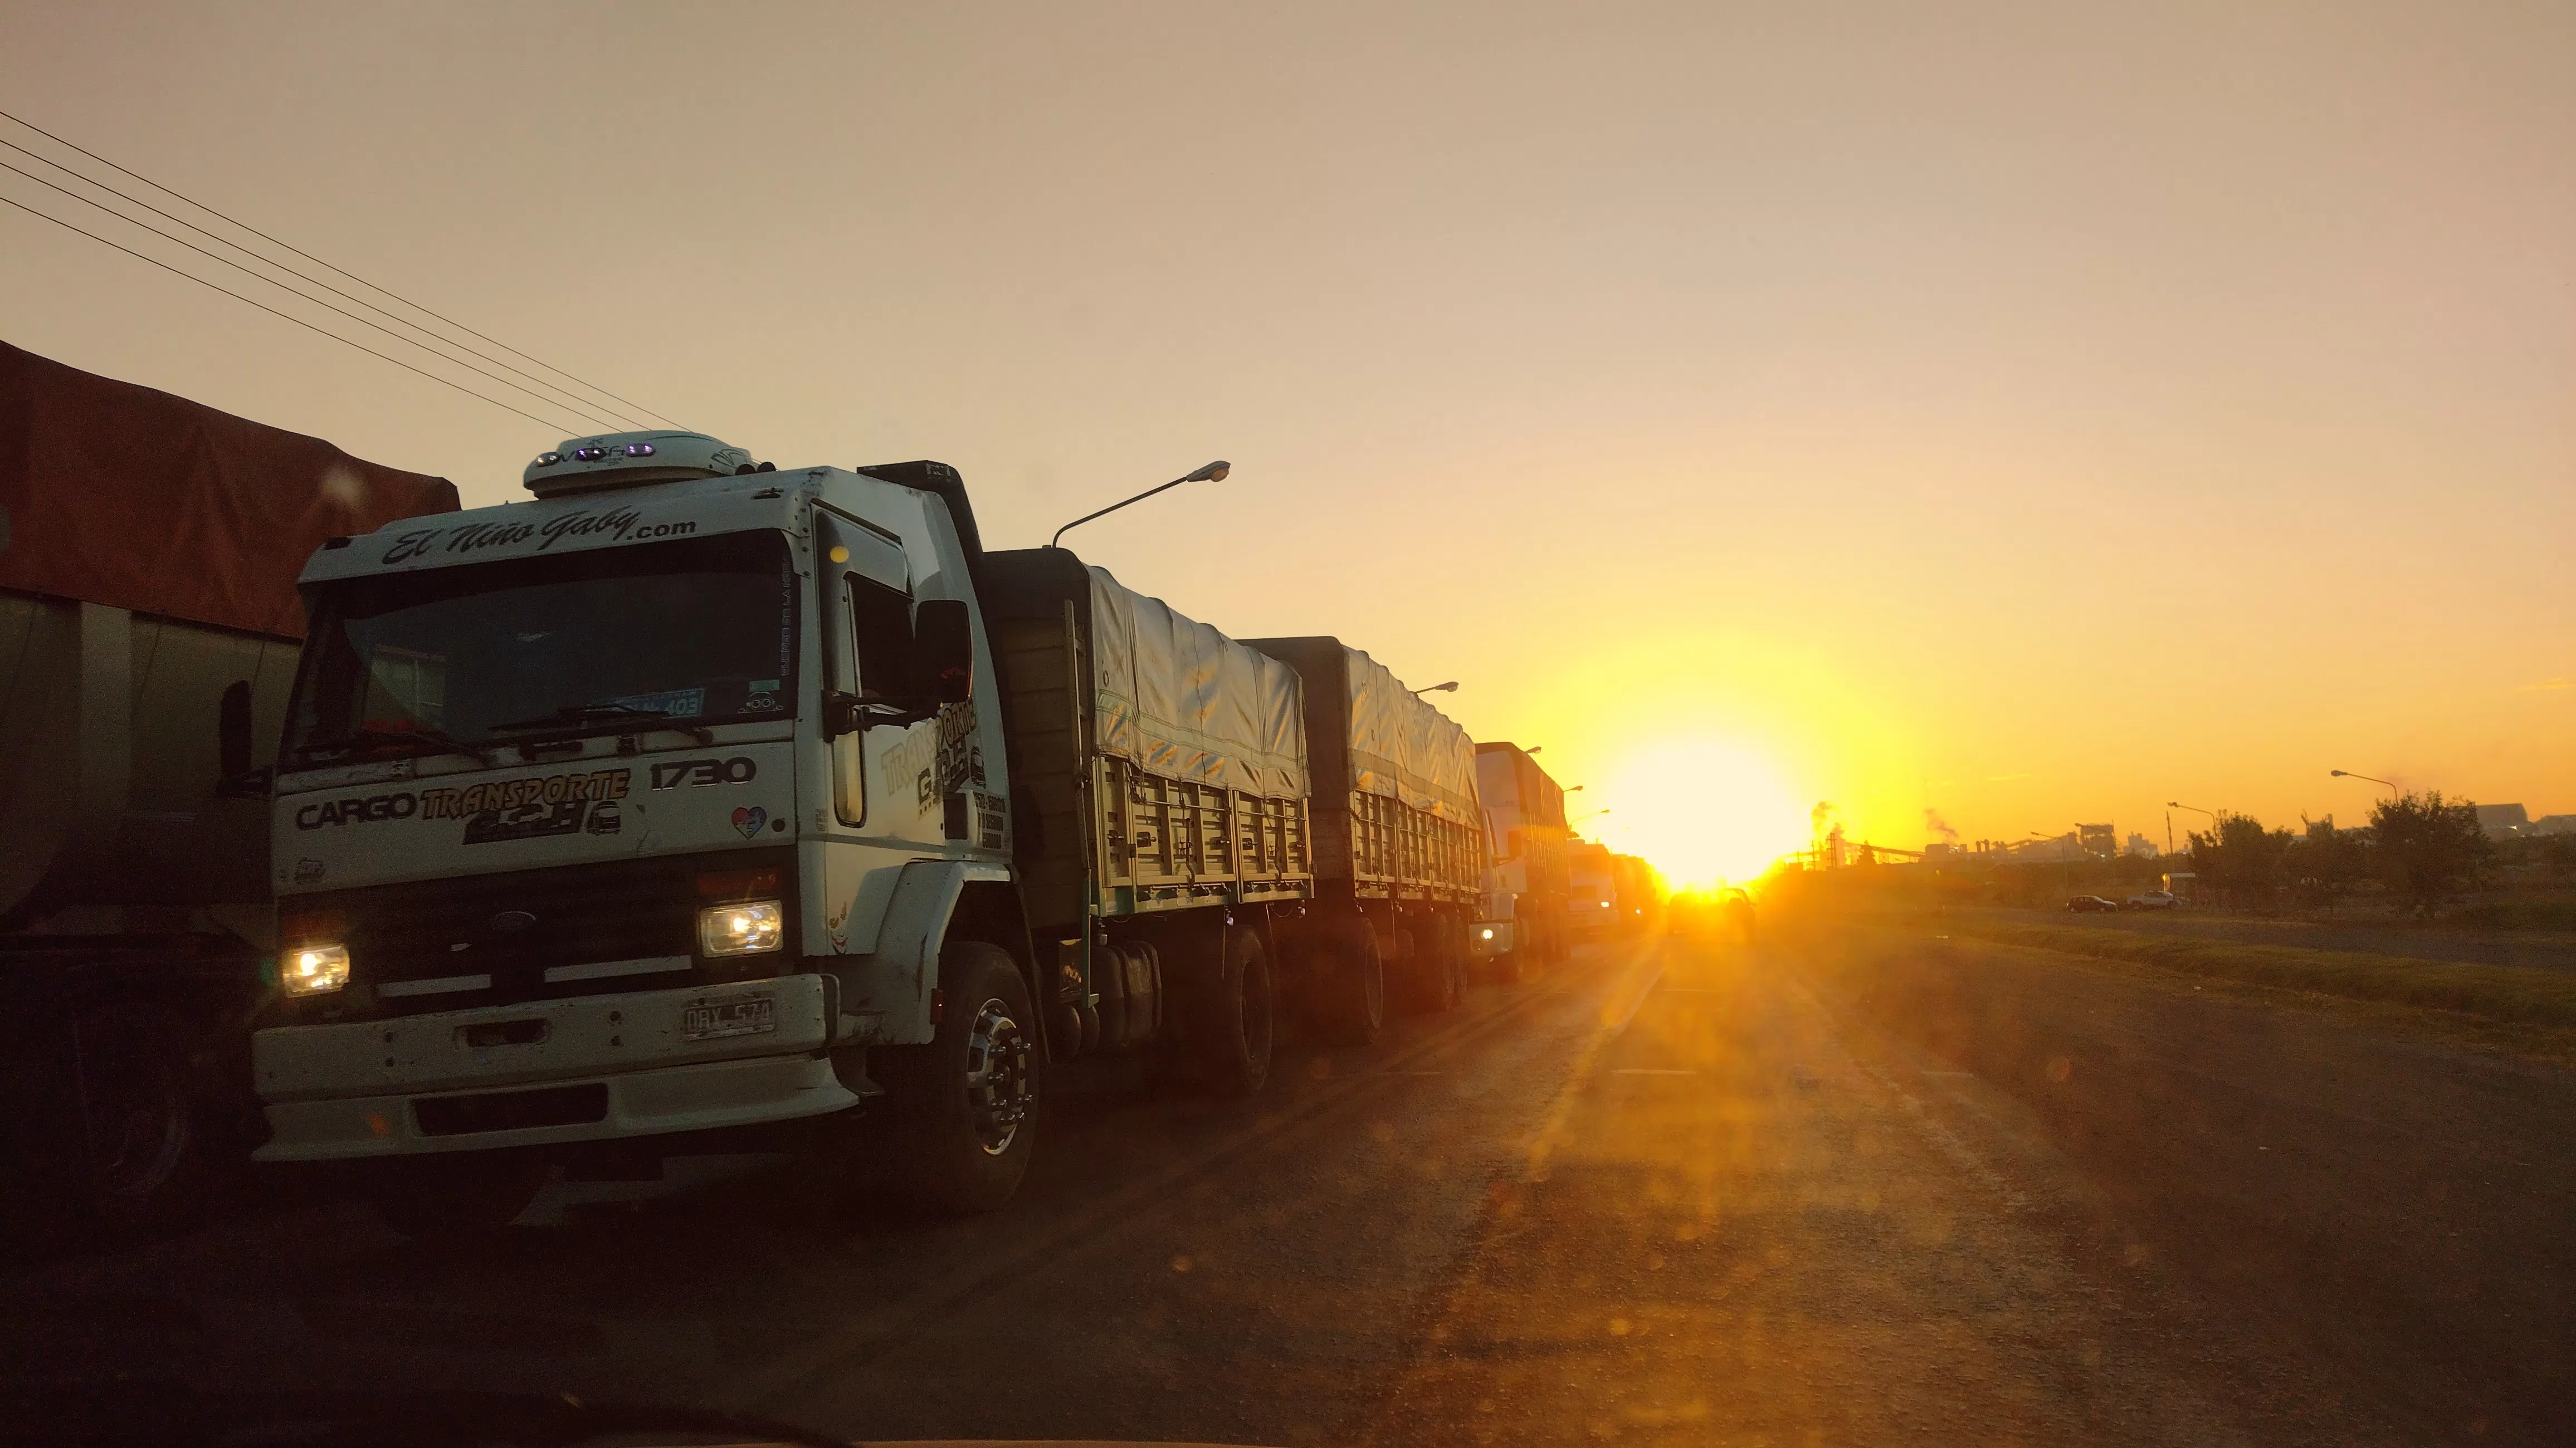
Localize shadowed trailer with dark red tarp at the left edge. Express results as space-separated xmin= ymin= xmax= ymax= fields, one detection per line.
xmin=0 ymin=343 xmax=456 ymax=1221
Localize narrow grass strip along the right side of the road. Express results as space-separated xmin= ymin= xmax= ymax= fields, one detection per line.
xmin=1942 ymin=920 xmax=2576 ymax=1031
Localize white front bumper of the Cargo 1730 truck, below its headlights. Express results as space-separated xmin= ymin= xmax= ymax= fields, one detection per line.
xmin=250 ymin=974 xmax=858 ymax=1162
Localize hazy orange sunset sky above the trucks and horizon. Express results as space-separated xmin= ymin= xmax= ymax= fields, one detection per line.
xmin=0 ymin=0 xmax=2576 ymax=876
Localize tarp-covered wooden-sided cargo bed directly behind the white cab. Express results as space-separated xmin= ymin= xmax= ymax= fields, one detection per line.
xmin=979 ymin=549 xmax=1314 ymax=1090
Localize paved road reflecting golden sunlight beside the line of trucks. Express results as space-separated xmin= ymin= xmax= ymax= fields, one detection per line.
xmin=0 ymin=941 xmax=2576 ymax=1443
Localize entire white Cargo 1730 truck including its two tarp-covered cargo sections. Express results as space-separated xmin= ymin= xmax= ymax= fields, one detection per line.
xmin=252 ymin=433 xmax=1474 ymax=1231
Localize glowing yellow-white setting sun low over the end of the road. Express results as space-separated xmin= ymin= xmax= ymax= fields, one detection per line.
xmin=1600 ymin=737 xmax=1808 ymax=889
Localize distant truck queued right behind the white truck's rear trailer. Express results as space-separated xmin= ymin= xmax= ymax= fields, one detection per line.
xmin=1468 ymin=740 xmax=1574 ymax=979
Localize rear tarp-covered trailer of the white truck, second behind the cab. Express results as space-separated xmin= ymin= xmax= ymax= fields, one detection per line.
xmin=1250 ymin=637 xmax=1486 ymax=1010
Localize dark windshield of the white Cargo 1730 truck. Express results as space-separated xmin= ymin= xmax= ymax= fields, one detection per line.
xmin=286 ymin=534 xmax=796 ymax=762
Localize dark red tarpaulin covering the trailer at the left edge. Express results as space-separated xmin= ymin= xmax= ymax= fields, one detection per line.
xmin=0 ymin=343 xmax=456 ymax=639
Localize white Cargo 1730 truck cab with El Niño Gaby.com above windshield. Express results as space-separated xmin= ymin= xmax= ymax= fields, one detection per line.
xmin=252 ymin=433 xmax=1046 ymax=1224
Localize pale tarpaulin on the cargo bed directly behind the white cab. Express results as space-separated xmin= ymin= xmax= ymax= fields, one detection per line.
xmin=1092 ymin=567 xmax=1308 ymax=799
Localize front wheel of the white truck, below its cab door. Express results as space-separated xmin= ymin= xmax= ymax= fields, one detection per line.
xmin=871 ymin=941 xmax=1043 ymax=1214
